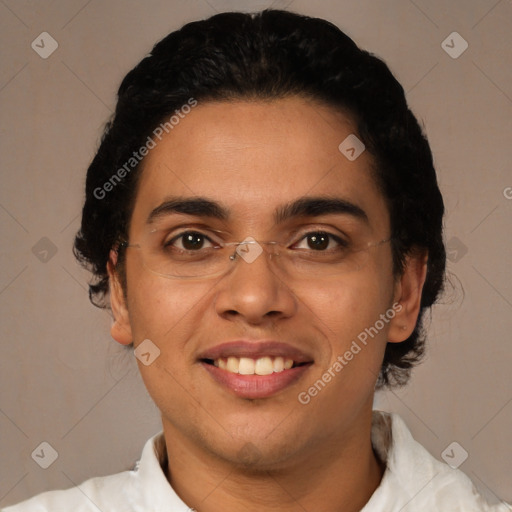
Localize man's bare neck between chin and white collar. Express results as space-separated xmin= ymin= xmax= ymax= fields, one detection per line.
xmin=164 ymin=410 xmax=384 ymax=512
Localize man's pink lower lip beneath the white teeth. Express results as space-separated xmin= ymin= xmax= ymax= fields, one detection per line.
xmin=201 ymin=362 xmax=311 ymax=399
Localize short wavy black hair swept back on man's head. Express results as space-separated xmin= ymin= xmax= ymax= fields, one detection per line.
xmin=74 ymin=9 xmax=446 ymax=388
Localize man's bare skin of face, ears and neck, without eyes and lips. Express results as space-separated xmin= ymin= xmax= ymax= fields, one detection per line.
xmin=108 ymin=97 xmax=426 ymax=512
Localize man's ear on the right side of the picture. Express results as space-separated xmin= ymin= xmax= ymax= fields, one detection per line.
xmin=388 ymin=250 xmax=428 ymax=343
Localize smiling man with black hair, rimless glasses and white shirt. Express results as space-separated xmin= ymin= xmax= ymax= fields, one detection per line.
xmin=7 ymin=10 xmax=508 ymax=512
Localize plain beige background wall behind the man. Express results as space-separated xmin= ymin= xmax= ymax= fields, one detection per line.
xmin=0 ymin=0 xmax=512 ymax=505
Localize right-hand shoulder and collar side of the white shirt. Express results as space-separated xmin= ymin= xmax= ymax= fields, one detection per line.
xmin=364 ymin=411 xmax=512 ymax=512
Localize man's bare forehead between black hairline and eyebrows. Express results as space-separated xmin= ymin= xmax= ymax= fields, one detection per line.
xmin=132 ymin=97 xmax=388 ymax=235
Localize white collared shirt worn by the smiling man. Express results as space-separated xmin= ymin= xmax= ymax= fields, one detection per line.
xmin=3 ymin=411 xmax=512 ymax=512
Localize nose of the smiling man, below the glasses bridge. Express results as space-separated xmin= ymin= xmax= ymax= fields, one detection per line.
xmin=215 ymin=246 xmax=297 ymax=325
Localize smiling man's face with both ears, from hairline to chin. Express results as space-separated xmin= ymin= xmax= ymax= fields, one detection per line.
xmin=110 ymin=97 xmax=424 ymax=468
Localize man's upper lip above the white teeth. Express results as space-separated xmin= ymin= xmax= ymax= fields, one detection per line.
xmin=199 ymin=340 xmax=313 ymax=363
